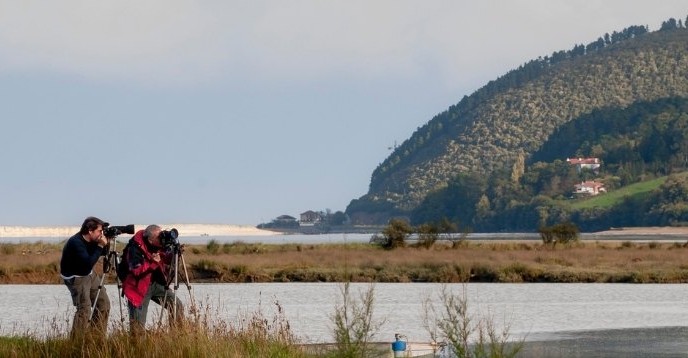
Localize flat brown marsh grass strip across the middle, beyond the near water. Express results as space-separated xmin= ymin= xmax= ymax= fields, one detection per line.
xmin=0 ymin=241 xmax=688 ymax=284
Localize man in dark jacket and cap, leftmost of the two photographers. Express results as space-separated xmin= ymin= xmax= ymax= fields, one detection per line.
xmin=60 ymin=216 xmax=110 ymax=337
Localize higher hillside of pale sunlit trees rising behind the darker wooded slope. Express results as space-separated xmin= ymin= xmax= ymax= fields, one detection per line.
xmin=347 ymin=19 xmax=688 ymax=229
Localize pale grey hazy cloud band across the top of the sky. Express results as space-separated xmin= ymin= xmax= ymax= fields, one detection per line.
xmin=0 ymin=0 xmax=681 ymax=86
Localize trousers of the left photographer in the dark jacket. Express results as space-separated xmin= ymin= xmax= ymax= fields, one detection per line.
xmin=64 ymin=273 xmax=110 ymax=337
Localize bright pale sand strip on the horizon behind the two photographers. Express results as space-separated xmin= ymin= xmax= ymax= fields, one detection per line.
xmin=0 ymin=224 xmax=275 ymax=238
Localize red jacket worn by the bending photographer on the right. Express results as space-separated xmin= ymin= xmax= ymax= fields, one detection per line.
xmin=122 ymin=230 xmax=169 ymax=307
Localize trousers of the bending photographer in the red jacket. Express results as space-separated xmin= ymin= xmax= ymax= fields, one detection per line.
xmin=127 ymin=282 xmax=184 ymax=330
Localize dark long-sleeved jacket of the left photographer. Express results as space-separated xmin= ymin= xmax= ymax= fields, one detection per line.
xmin=60 ymin=233 xmax=106 ymax=277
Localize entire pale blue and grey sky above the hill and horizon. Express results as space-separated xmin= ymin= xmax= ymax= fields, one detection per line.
xmin=0 ymin=0 xmax=688 ymax=226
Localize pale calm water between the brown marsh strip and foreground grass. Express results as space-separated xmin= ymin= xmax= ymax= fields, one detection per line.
xmin=0 ymin=283 xmax=688 ymax=342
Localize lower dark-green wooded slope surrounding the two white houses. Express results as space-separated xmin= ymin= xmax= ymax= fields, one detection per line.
xmin=408 ymin=97 xmax=688 ymax=231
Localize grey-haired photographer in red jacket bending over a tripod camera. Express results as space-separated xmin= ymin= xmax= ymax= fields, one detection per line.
xmin=122 ymin=225 xmax=184 ymax=331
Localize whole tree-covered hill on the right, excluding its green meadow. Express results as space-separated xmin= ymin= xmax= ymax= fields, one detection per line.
xmin=347 ymin=19 xmax=688 ymax=231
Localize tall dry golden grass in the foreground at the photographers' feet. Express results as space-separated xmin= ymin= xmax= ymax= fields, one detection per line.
xmin=0 ymin=303 xmax=307 ymax=358
